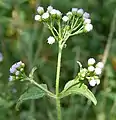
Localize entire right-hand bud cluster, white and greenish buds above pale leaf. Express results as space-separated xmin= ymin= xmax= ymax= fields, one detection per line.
xmin=78 ymin=58 xmax=104 ymax=86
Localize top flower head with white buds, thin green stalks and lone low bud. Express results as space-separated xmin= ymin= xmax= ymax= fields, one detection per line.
xmin=35 ymin=6 xmax=93 ymax=44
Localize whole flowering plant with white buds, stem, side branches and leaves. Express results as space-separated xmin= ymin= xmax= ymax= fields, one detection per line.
xmin=9 ymin=6 xmax=104 ymax=120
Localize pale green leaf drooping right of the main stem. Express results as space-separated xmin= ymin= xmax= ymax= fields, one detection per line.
xmin=60 ymin=80 xmax=97 ymax=105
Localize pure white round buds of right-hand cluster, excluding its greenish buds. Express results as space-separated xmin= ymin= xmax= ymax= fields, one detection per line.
xmin=86 ymin=58 xmax=104 ymax=86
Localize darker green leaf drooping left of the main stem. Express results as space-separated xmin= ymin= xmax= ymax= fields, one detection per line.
xmin=16 ymin=84 xmax=47 ymax=110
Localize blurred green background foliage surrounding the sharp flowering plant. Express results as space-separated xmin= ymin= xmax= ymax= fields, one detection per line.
xmin=0 ymin=0 xmax=116 ymax=120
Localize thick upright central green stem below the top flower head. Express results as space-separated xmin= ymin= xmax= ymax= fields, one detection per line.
xmin=56 ymin=42 xmax=63 ymax=120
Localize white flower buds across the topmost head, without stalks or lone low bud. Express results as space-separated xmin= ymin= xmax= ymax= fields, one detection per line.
xmin=35 ymin=6 xmax=93 ymax=32
